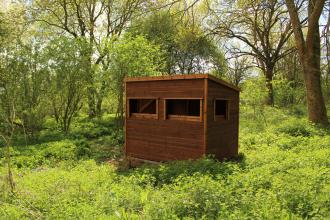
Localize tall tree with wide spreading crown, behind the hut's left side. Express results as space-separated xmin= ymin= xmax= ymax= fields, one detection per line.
xmin=31 ymin=0 xmax=146 ymax=117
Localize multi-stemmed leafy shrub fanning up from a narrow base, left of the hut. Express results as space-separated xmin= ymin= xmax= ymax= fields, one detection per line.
xmin=46 ymin=37 xmax=88 ymax=133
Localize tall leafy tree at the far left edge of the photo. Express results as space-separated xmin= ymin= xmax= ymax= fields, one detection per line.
xmin=0 ymin=5 xmax=46 ymax=138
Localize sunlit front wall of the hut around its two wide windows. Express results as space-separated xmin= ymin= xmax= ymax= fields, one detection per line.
xmin=125 ymin=79 xmax=204 ymax=161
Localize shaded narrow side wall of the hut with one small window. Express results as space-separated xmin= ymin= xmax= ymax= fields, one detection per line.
xmin=206 ymin=80 xmax=239 ymax=159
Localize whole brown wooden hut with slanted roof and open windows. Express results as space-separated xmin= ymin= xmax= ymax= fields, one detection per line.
xmin=125 ymin=74 xmax=239 ymax=161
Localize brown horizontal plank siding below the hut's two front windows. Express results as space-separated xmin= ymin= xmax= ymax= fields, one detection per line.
xmin=126 ymin=119 xmax=203 ymax=161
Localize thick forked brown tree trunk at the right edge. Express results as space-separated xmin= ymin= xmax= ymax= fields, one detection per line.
xmin=285 ymin=0 xmax=328 ymax=125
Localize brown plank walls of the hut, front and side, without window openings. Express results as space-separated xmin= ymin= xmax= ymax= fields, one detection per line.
xmin=125 ymin=77 xmax=239 ymax=161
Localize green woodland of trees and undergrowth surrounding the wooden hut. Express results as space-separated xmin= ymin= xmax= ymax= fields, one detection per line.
xmin=0 ymin=0 xmax=330 ymax=219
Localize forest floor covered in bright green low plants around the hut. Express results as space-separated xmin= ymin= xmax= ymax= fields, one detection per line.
xmin=0 ymin=106 xmax=330 ymax=219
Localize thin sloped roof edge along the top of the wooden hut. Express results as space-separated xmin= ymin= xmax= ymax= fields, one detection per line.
xmin=125 ymin=74 xmax=240 ymax=91
